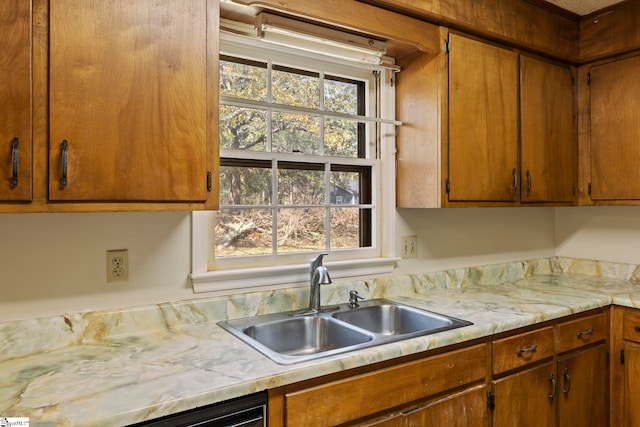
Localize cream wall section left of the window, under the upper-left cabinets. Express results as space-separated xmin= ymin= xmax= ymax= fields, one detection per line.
xmin=0 ymin=212 xmax=193 ymax=321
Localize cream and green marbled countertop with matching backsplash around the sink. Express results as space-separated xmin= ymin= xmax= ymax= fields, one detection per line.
xmin=0 ymin=258 xmax=640 ymax=426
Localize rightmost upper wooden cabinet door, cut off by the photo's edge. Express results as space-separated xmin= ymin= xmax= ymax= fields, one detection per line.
xmin=590 ymin=57 xmax=640 ymax=200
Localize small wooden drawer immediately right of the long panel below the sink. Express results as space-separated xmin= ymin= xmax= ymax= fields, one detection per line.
xmin=492 ymin=326 xmax=554 ymax=374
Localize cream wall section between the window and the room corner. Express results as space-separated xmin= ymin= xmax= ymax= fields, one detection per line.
xmin=396 ymin=207 xmax=555 ymax=274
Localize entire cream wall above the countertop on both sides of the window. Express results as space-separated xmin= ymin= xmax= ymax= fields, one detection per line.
xmin=0 ymin=207 xmax=640 ymax=321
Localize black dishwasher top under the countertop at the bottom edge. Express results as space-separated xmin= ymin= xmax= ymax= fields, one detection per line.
xmin=130 ymin=391 xmax=267 ymax=427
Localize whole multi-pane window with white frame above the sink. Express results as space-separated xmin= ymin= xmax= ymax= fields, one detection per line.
xmin=192 ymin=24 xmax=395 ymax=290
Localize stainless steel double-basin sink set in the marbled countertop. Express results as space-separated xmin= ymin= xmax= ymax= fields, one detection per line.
xmin=218 ymin=299 xmax=472 ymax=365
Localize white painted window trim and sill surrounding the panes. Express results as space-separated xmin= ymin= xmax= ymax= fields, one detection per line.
xmin=189 ymin=27 xmax=398 ymax=294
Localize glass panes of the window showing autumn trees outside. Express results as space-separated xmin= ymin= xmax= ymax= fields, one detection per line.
xmin=216 ymin=58 xmax=373 ymax=256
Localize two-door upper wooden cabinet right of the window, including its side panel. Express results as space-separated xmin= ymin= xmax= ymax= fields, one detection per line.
xmin=396 ymin=33 xmax=577 ymax=208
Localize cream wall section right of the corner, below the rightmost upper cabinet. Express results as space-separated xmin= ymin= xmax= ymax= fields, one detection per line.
xmin=556 ymin=206 xmax=640 ymax=264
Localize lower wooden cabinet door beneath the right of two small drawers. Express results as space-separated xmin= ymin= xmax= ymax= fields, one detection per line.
xmin=558 ymin=344 xmax=609 ymax=427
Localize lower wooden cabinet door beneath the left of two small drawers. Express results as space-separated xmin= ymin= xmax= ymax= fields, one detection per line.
xmin=493 ymin=362 xmax=556 ymax=427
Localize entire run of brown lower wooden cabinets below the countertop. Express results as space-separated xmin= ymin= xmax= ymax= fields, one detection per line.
xmin=269 ymin=311 xmax=608 ymax=427
